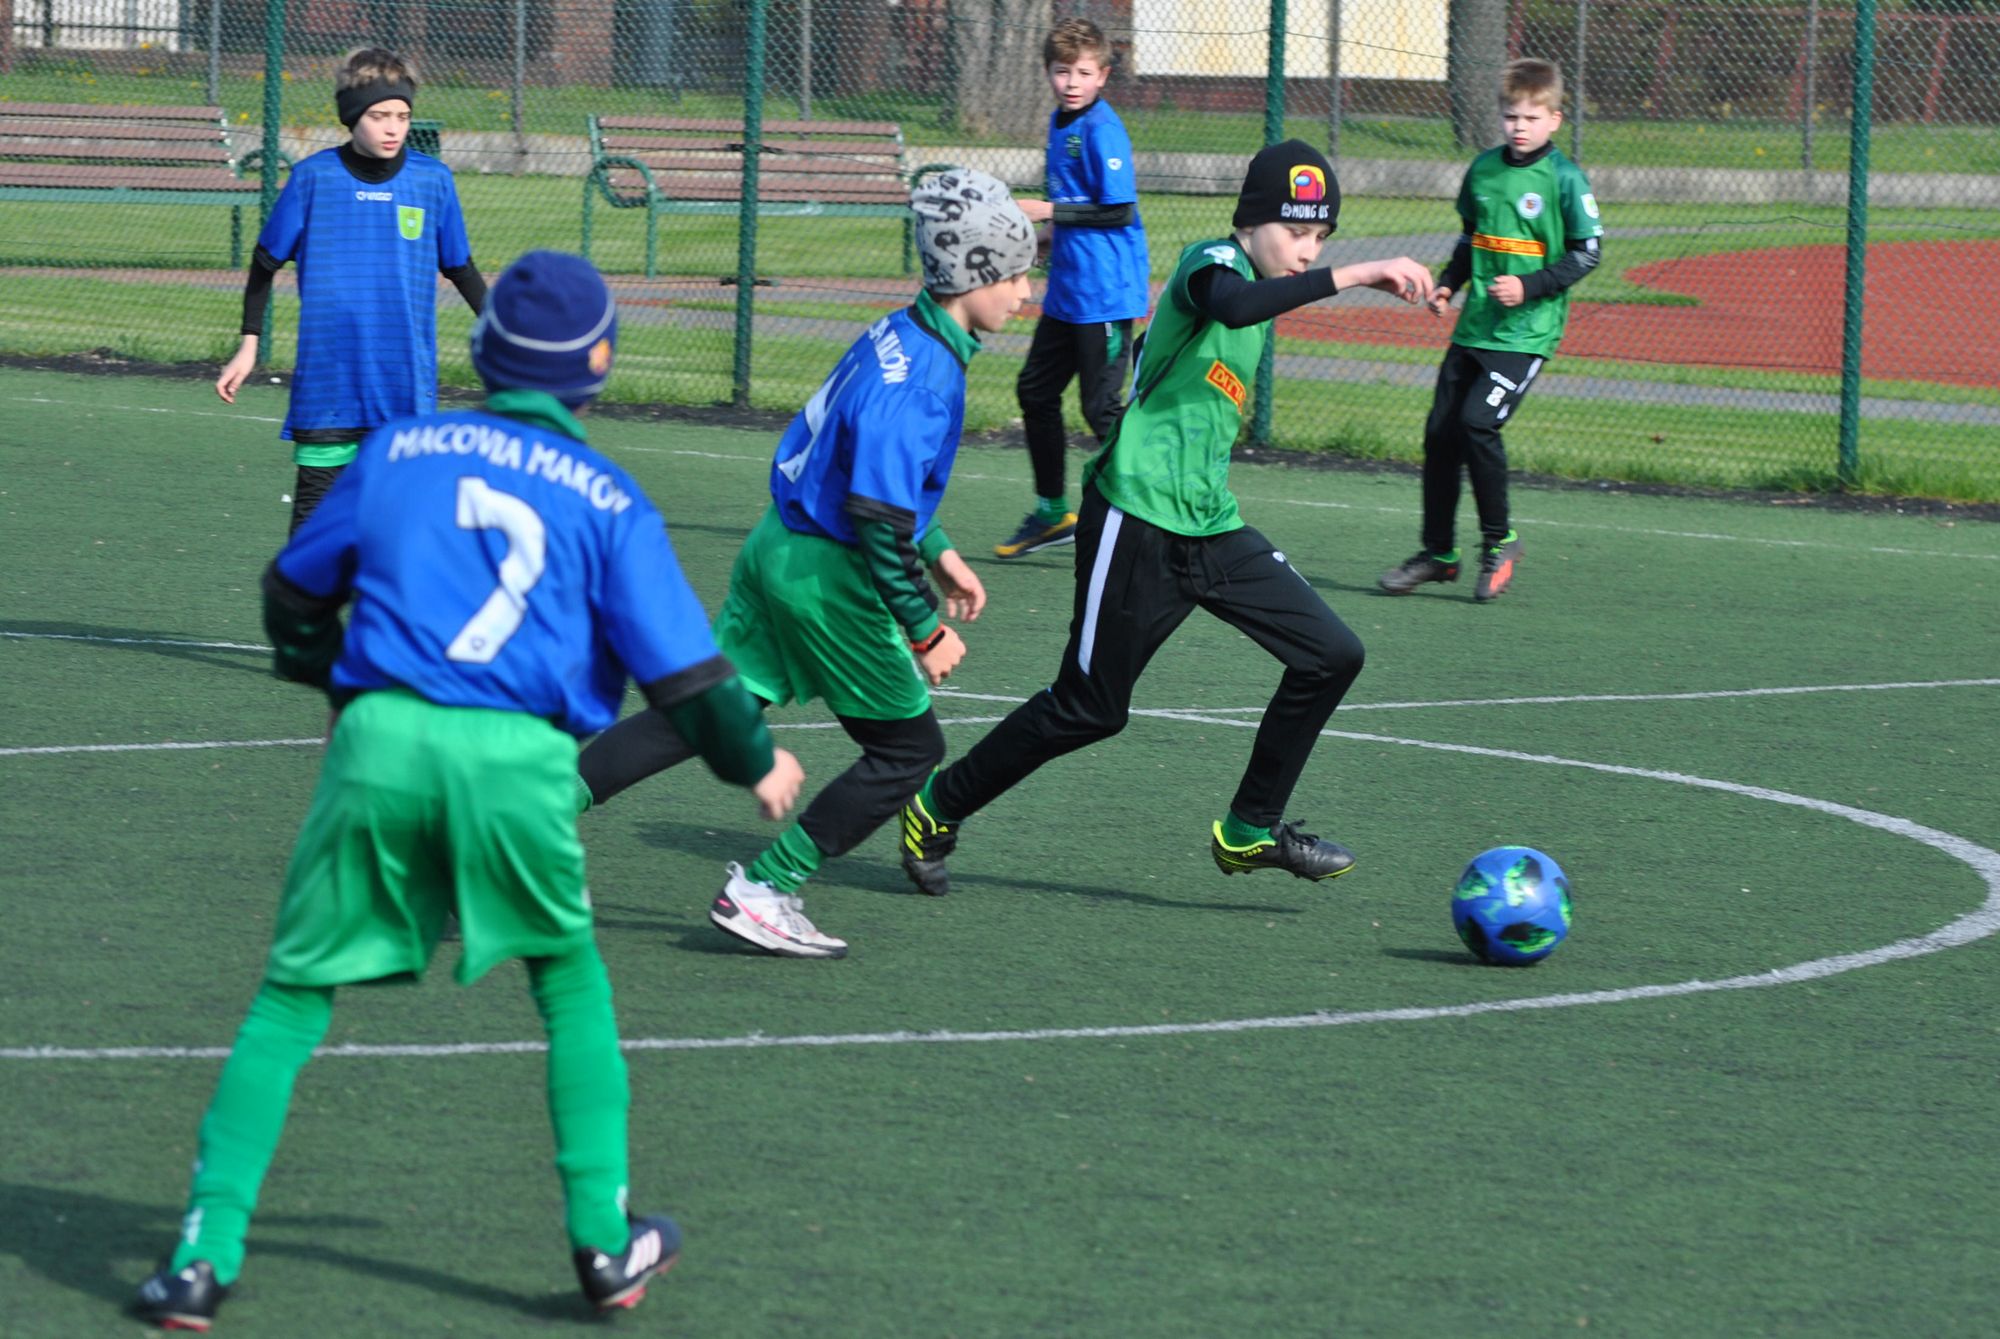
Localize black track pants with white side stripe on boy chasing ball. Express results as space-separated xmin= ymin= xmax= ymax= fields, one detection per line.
xmin=932 ymin=488 xmax=1362 ymax=827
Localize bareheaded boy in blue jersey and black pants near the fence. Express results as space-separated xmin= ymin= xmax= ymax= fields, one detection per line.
xmin=994 ymin=18 xmax=1150 ymax=558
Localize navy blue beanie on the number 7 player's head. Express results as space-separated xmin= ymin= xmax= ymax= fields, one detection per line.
xmin=472 ymin=252 xmax=618 ymax=410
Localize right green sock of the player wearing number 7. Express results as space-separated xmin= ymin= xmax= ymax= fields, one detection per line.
xmin=528 ymin=943 xmax=632 ymax=1253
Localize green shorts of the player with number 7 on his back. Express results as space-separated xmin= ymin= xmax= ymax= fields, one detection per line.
xmin=264 ymin=691 xmax=590 ymax=985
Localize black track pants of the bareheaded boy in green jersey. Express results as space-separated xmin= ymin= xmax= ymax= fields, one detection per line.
xmin=1422 ymin=344 xmax=1546 ymax=554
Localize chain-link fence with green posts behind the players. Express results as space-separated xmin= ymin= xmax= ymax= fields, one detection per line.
xmin=0 ymin=0 xmax=2000 ymax=500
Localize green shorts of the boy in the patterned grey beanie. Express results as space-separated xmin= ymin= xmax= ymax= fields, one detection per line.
xmin=716 ymin=508 xmax=930 ymax=721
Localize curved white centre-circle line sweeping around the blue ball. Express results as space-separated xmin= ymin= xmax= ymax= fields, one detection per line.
xmin=0 ymin=713 xmax=2000 ymax=1061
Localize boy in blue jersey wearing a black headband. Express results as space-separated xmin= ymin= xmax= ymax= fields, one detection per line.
xmin=216 ymin=48 xmax=486 ymax=534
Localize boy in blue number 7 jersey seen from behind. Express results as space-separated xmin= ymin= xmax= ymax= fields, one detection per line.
xmin=138 ymin=252 xmax=802 ymax=1329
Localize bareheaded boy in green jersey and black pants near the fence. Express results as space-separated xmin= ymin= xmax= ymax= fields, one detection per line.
xmin=1378 ymin=60 xmax=1604 ymax=602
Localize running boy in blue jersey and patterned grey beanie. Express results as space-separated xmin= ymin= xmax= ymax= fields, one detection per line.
xmin=580 ymin=168 xmax=1034 ymax=957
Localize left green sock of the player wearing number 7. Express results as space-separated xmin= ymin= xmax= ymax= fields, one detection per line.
xmin=172 ymin=981 xmax=334 ymax=1285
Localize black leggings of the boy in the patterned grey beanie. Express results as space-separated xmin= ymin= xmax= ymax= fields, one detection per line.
xmin=576 ymin=707 xmax=944 ymax=855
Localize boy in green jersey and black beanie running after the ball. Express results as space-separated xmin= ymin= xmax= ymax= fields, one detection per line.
xmin=902 ymin=140 xmax=1430 ymax=893
